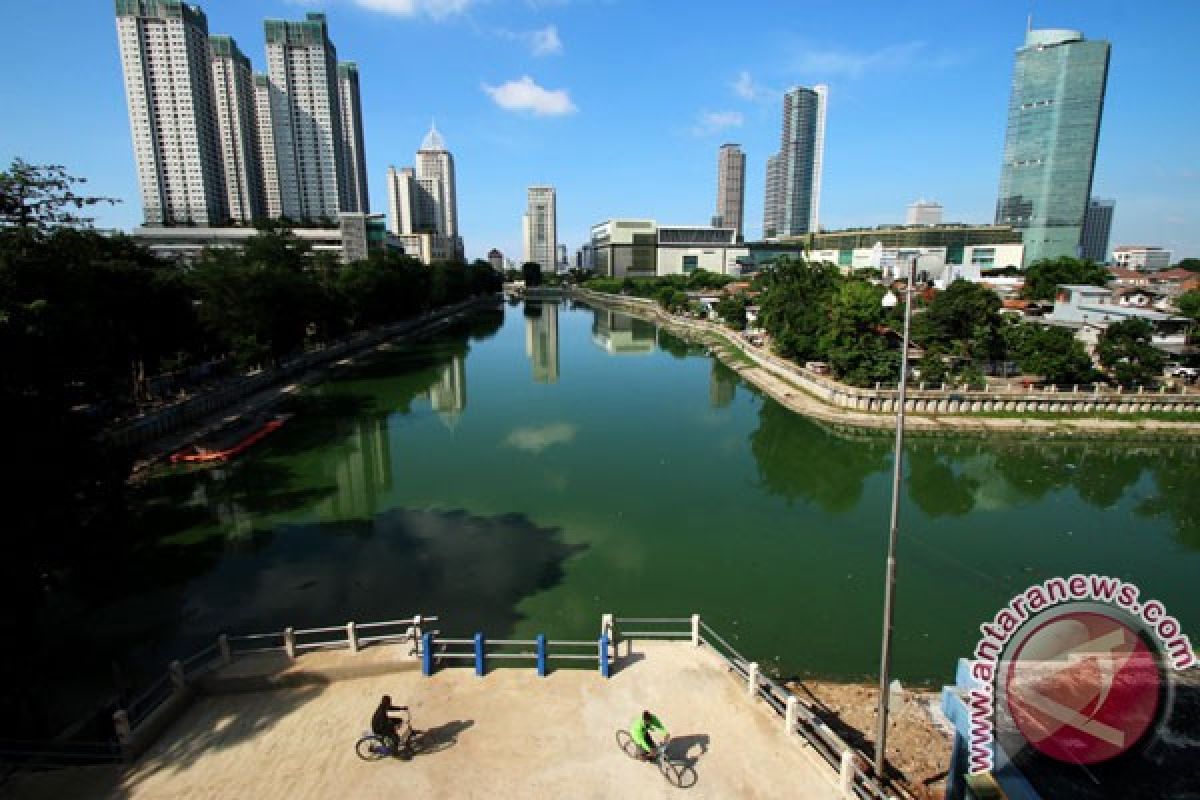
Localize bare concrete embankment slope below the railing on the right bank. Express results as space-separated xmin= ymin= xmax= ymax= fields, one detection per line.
xmin=569 ymin=289 xmax=1200 ymax=439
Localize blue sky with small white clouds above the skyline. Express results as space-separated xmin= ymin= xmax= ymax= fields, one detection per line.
xmin=0 ymin=0 xmax=1200 ymax=259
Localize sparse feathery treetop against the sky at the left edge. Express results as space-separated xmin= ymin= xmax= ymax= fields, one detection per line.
xmin=0 ymin=158 xmax=120 ymax=234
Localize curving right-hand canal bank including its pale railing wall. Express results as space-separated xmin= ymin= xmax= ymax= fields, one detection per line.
xmin=569 ymin=288 xmax=1200 ymax=440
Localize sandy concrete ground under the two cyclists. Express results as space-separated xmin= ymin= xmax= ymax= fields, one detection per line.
xmin=0 ymin=643 xmax=836 ymax=800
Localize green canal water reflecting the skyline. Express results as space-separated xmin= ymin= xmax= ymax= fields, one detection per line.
xmin=112 ymin=303 xmax=1200 ymax=684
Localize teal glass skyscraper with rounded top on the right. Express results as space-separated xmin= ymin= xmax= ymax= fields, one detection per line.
xmin=996 ymin=30 xmax=1109 ymax=264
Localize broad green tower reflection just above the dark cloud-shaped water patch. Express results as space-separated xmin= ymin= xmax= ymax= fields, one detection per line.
xmin=317 ymin=417 xmax=392 ymax=519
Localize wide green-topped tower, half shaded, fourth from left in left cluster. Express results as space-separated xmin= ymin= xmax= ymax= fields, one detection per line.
xmin=265 ymin=12 xmax=349 ymax=219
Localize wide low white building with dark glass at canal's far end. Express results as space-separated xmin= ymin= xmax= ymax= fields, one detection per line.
xmin=592 ymin=219 xmax=750 ymax=278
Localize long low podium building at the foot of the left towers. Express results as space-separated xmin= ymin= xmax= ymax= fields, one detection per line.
xmin=132 ymin=213 xmax=407 ymax=264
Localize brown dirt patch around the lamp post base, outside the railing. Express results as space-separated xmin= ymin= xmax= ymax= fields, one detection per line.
xmin=787 ymin=680 xmax=954 ymax=800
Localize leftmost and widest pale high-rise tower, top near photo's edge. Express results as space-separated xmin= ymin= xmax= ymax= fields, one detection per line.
xmin=116 ymin=0 xmax=228 ymax=225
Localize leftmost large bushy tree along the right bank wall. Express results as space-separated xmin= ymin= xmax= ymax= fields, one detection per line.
xmin=755 ymin=258 xmax=845 ymax=361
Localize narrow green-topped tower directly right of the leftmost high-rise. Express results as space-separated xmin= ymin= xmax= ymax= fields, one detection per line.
xmin=209 ymin=36 xmax=266 ymax=223
